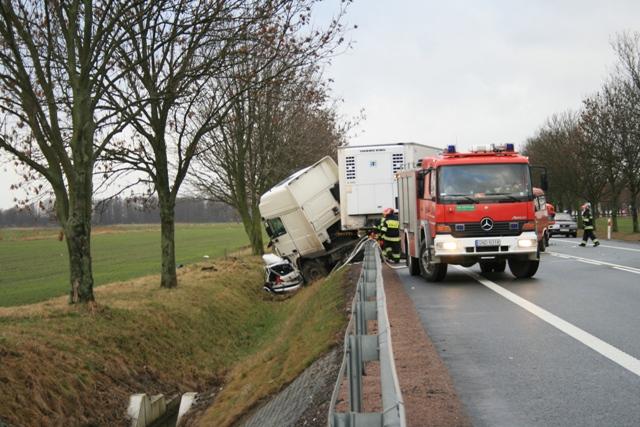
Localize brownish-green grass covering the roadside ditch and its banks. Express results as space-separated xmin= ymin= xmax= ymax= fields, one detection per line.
xmin=0 ymin=255 xmax=346 ymax=426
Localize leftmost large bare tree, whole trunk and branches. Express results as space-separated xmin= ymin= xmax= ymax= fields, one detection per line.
xmin=0 ymin=0 xmax=137 ymax=303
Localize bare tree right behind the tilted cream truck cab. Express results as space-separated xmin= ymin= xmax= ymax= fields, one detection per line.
xmin=192 ymin=61 xmax=347 ymax=254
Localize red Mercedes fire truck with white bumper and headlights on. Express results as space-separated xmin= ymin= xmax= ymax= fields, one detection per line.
xmin=396 ymin=144 xmax=547 ymax=281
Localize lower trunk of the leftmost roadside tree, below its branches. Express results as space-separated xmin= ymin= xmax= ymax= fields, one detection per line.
xmin=64 ymin=209 xmax=95 ymax=304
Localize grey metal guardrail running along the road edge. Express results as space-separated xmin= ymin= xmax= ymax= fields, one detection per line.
xmin=328 ymin=241 xmax=406 ymax=427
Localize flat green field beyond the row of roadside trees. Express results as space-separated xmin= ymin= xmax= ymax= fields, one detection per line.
xmin=0 ymin=224 xmax=248 ymax=307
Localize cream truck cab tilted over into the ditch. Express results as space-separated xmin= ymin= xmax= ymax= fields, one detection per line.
xmin=259 ymin=156 xmax=340 ymax=264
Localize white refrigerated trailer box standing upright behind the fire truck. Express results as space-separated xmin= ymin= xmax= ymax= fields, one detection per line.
xmin=338 ymin=142 xmax=442 ymax=230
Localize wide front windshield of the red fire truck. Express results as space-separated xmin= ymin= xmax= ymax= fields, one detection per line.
xmin=437 ymin=163 xmax=532 ymax=203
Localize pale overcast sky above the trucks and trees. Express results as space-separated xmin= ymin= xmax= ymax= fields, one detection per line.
xmin=0 ymin=0 xmax=640 ymax=208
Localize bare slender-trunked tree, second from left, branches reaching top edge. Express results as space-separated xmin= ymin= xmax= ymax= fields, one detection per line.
xmin=108 ymin=0 xmax=350 ymax=287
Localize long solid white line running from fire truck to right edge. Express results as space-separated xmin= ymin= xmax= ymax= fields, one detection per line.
xmin=456 ymin=266 xmax=640 ymax=376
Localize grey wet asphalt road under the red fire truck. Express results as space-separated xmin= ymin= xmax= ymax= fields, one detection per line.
xmin=398 ymin=237 xmax=640 ymax=427
